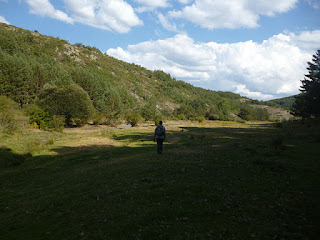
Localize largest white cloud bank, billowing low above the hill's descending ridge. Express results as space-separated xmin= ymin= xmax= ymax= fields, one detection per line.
xmin=107 ymin=31 xmax=320 ymax=100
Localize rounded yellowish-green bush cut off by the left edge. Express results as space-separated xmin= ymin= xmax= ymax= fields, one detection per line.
xmin=0 ymin=96 xmax=27 ymax=133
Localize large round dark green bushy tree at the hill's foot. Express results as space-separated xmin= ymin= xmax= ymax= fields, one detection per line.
xmin=38 ymin=84 xmax=94 ymax=124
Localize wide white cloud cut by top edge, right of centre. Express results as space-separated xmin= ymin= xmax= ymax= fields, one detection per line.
xmin=169 ymin=0 xmax=298 ymax=29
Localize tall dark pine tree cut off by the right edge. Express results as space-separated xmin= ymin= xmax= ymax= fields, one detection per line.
xmin=293 ymin=50 xmax=320 ymax=118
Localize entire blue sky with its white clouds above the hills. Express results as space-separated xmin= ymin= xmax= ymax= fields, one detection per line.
xmin=0 ymin=0 xmax=320 ymax=100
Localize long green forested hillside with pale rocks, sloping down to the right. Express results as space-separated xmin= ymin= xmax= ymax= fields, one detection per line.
xmin=0 ymin=23 xmax=268 ymax=123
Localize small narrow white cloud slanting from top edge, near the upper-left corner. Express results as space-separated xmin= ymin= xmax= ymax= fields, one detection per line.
xmin=26 ymin=0 xmax=74 ymax=23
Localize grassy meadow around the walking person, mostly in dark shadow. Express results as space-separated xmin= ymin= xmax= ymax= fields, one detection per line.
xmin=0 ymin=122 xmax=320 ymax=239
